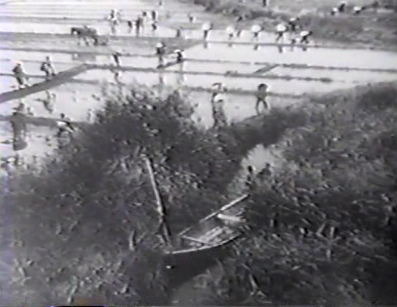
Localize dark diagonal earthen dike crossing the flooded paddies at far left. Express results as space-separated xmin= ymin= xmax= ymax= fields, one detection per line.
xmin=0 ymin=64 xmax=88 ymax=103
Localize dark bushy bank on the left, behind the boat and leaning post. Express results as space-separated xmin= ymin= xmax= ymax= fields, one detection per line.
xmin=0 ymin=85 xmax=304 ymax=305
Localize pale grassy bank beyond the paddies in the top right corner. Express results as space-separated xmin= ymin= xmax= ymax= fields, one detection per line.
xmin=188 ymin=0 xmax=397 ymax=50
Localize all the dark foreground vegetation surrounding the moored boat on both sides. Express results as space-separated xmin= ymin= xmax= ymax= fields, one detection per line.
xmin=0 ymin=83 xmax=397 ymax=305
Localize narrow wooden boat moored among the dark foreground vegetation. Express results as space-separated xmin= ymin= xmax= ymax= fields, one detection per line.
xmin=164 ymin=194 xmax=249 ymax=267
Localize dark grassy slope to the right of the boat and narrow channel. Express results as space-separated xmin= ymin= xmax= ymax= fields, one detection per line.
xmin=174 ymin=83 xmax=397 ymax=306
